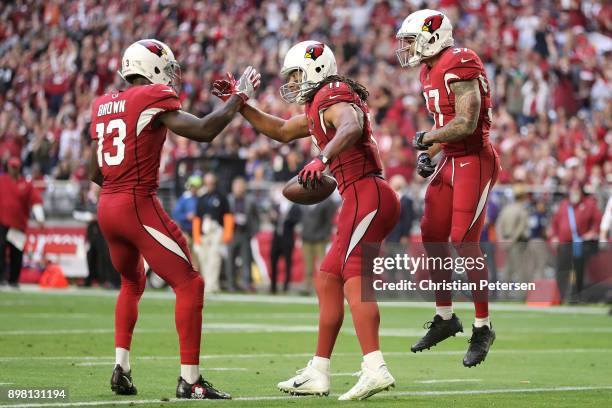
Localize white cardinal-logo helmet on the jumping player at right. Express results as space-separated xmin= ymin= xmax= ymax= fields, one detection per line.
xmin=395 ymin=9 xmax=455 ymax=68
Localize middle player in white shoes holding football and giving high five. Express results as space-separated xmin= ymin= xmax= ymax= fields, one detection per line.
xmin=213 ymin=41 xmax=399 ymax=400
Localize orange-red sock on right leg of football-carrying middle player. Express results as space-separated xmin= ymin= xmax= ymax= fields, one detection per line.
xmin=344 ymin=276 xmax=380 ymax=355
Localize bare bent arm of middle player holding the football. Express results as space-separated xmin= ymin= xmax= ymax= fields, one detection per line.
xmin=321 ymin=102 xmax=363 ymax=161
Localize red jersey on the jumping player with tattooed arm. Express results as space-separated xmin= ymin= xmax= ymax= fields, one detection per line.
xmin=420 ymin=48 xmax=491 ymax=156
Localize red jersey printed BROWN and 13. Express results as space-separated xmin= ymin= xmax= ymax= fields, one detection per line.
xmin=90 ymin=84 xmax=181 ymax=195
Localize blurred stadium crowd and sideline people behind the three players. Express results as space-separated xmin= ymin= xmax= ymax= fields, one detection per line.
xmin=0 ymin=0 xmax=612 ymax=301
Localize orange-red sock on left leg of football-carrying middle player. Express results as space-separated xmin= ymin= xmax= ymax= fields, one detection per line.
xmin=315 ymin=271 xmax=344 ymax=358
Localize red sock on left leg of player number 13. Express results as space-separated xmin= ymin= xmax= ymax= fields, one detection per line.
xmin=115 ymin=272 xmax=146 ymax=350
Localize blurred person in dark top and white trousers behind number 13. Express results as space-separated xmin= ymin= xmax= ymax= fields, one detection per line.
xmin=194 ymin=173 xmax=229 ymax=293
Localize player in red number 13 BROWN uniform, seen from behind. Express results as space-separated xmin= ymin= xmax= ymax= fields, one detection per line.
xmin=90 ymin=39 xmax=260 ymax=399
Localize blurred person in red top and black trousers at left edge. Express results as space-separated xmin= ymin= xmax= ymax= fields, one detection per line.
xmin=0 ymin=157 xmax=45 ymax=288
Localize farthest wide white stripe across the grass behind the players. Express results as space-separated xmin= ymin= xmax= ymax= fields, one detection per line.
xmin=9 ymin=285 xmax=608 ymax=315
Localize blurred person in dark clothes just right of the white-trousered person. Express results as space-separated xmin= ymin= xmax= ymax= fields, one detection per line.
xmin=225 ymin=177 xmax=259 ymax=291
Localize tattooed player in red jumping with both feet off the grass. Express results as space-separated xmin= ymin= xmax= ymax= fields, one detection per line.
xmin=397 ymin=10 xmax=500 ymax=367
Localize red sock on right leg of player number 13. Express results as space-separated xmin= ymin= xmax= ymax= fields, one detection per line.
xmin=173 ymin=273 xmax=204 ymax=365
